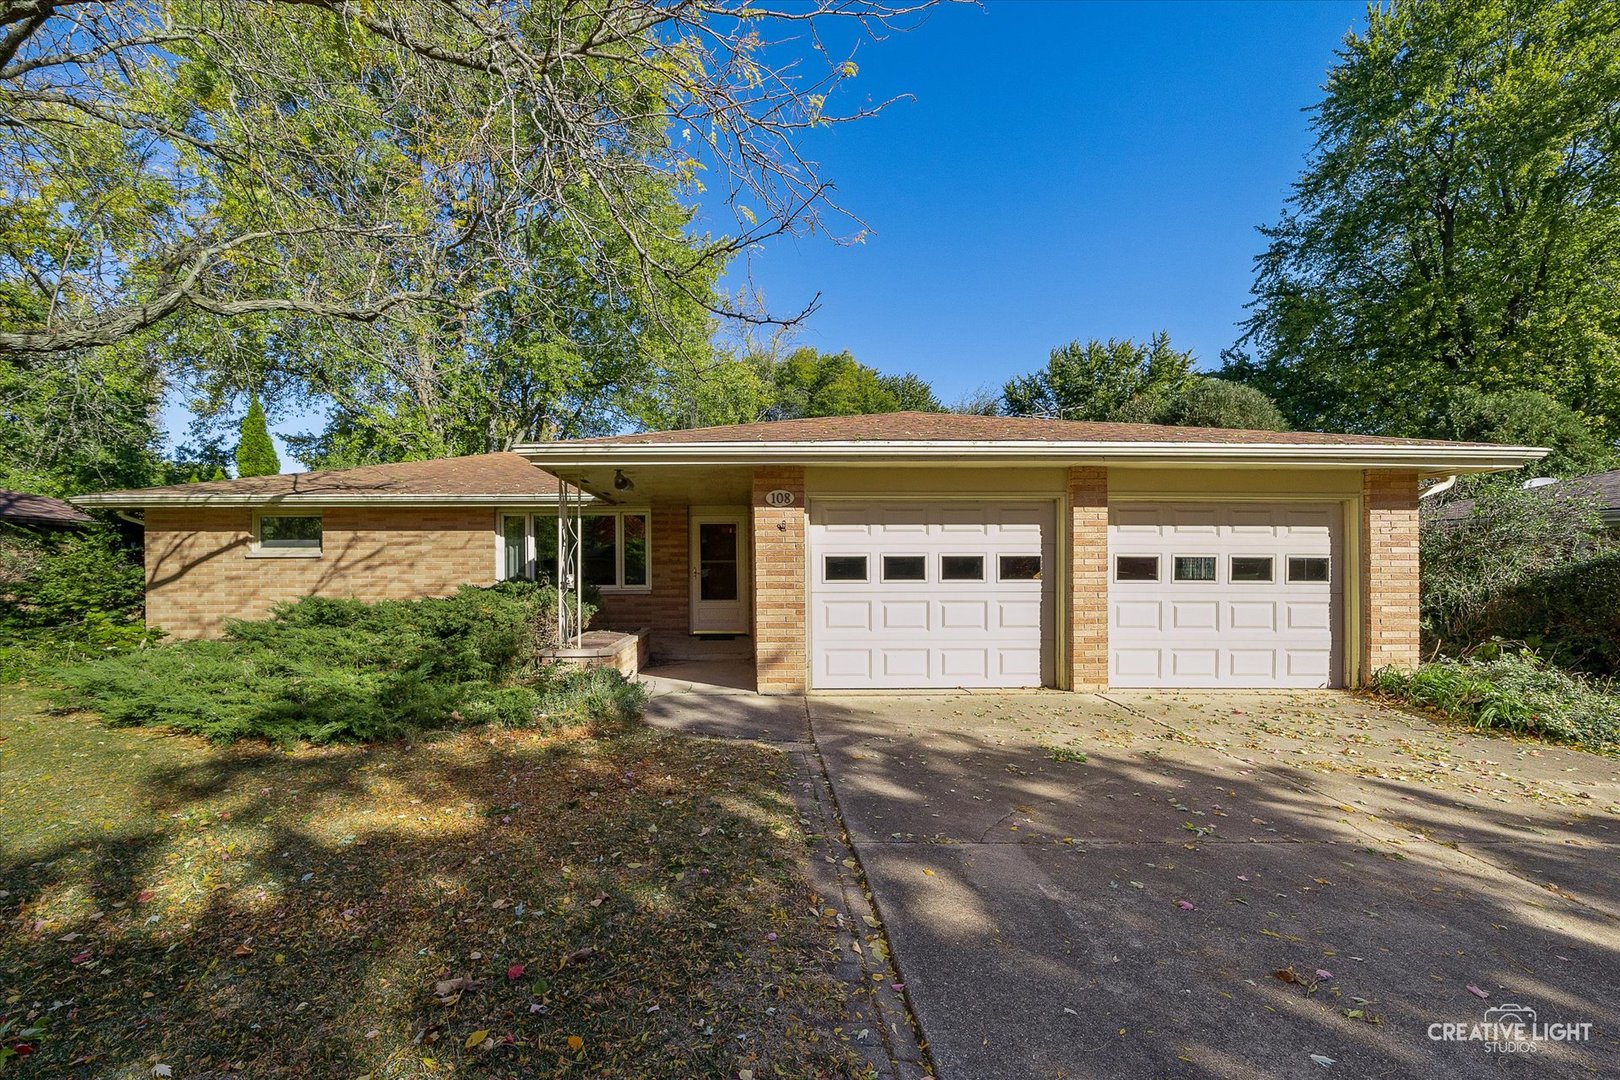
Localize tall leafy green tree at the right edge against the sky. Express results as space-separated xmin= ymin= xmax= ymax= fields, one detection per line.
xmin=1226 ymin=0 xmax=1620 ymax=437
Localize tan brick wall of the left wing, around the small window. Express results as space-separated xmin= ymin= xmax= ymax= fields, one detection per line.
xmin=146 ymin=507 xmax=496 ymax=638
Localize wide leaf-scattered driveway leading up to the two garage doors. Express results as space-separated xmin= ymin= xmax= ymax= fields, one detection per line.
xmin=810 ymin=691 xmax=1620 ymax=1078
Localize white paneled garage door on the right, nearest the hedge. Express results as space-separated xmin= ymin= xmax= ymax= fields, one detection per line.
xmin=1108 ymin=502 xmax=1345 ymax=687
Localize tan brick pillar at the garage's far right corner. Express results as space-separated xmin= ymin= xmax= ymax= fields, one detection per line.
xmin=1361 ymin=470 xmax=1421 ymax=680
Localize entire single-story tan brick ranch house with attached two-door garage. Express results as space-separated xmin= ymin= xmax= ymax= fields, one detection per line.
xmin=78 ymin=413 xmax=1545 ymax=693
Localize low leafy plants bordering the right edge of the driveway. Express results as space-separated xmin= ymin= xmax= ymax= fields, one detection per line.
xmin=1372 ymin=649 xmax=1620 ymax=753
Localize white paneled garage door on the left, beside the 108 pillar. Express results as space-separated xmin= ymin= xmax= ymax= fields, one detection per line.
xmin=808 ymin=500 xmax=1056 ymax=690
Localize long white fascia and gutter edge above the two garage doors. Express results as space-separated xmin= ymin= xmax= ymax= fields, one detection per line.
xmin=514 ymin=440 xmax=1549 ymax=473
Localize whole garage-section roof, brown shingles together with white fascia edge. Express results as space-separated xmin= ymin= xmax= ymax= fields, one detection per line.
xmin=517 ymin=413 xmax=1547 ymax=471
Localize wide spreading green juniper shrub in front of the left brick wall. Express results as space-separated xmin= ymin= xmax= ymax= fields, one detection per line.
xmin=45 ymin=581 xmax=642 ymax=743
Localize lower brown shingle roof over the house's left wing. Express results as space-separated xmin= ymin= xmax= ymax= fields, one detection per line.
xmin=73 ymin=453 xmax=557 ymax=507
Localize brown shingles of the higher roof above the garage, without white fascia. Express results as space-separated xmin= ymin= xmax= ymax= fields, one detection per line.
xmin=554 ymin=413 xmax=1503 ymax=447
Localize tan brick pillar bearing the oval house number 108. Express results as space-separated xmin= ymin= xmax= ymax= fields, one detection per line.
xmin=753 ymin=466 xmax=807 ymax=693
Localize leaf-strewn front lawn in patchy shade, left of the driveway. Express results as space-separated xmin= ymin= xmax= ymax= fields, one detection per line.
xmin=0 ymin=691 xmax=862 ymax=1078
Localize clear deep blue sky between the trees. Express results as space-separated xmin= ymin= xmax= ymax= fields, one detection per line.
xmin=183 ymin=0 xmax=1366 ymax=468
